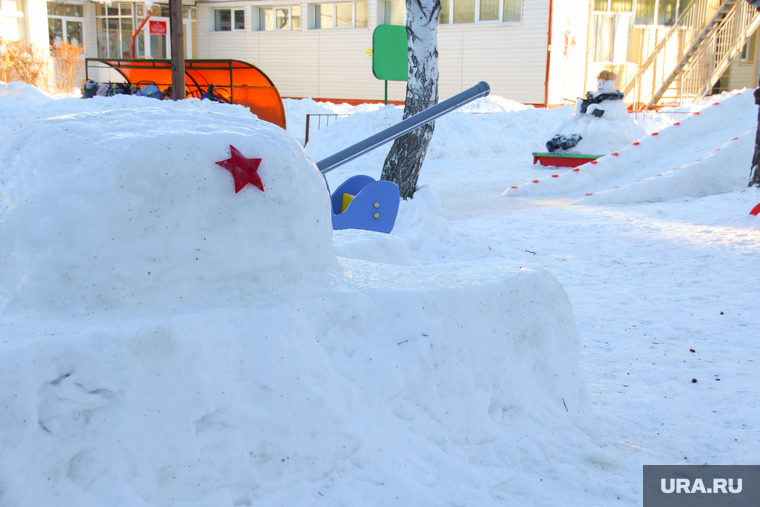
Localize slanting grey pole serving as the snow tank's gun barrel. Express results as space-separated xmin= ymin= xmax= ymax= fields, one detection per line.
xmin=317 ymin=81 xmax=491 ymax=174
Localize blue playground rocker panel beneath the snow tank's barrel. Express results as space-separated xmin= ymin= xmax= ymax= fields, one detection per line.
xmin=325 ymin=175 xmax=401 ymax=234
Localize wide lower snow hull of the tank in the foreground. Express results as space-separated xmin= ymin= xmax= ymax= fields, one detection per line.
xmin=0 ymin=261 xmax=596 ymax=507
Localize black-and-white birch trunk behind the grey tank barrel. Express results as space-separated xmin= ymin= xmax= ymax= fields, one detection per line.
xmin=380 ymin=0 xmax=441 ymax=199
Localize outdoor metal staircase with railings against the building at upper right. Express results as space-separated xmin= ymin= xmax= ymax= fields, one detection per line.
xmin=623 ymin=0 xmax=760 ymax=110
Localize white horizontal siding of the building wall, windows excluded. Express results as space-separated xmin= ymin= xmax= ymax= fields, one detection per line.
xmin=197 ymin=0 xmax=561 ymax=104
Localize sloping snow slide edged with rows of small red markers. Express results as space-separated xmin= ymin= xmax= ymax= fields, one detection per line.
xmin=502 ymin=90 xmax=757 ymax=203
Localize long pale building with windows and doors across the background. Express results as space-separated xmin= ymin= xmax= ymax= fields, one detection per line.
xmin=5 ymin=0 xmax=760 ymax=106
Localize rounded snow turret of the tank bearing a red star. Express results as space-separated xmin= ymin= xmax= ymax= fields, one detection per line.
xmin=0 ymin=109 xmax=337 ymax=309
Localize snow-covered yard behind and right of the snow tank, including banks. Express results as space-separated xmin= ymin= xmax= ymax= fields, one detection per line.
xmin=302 ymin=90 xmax=760 ymax=496
